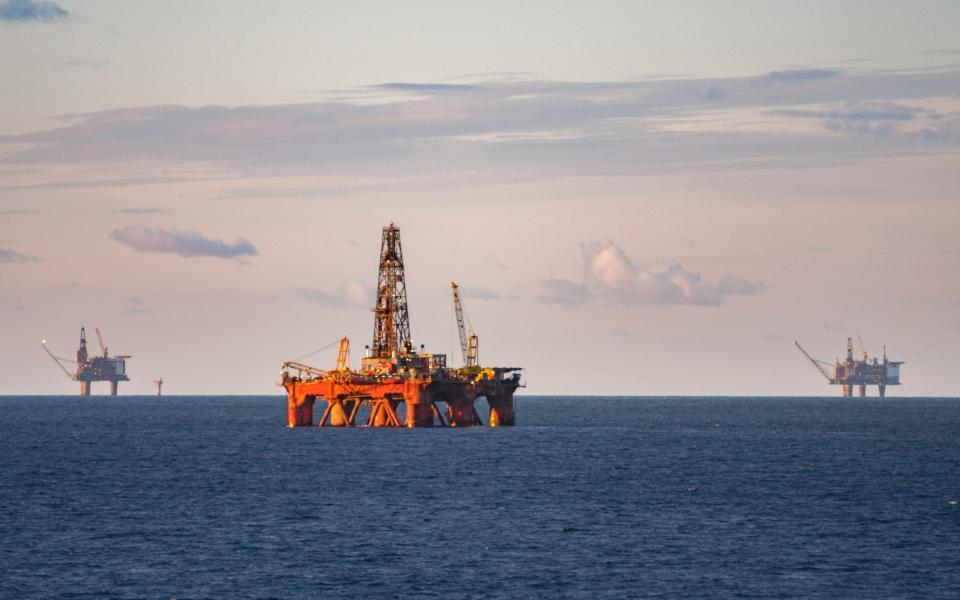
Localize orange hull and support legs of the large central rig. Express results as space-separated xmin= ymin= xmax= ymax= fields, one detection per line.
xmin=283 ymin=374 xmax=519 ymax=427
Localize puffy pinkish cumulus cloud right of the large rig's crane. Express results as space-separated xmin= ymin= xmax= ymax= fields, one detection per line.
xmin=540 ymin=239 xmax=763 ymax=307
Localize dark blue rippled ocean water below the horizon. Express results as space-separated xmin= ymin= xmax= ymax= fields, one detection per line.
xmin=0 ymin=397 xmax=960 ymax=599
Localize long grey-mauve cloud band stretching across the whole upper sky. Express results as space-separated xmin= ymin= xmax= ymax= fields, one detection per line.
xmin=0 ymin=69 xmax=960 ymax=188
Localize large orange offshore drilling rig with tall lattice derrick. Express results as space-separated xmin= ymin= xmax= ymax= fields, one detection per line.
xmin=281 ymin=223 xmax=521 ymax=427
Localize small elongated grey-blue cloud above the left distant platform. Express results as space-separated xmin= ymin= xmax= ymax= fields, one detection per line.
xmin=110 ymin=224 xmax=258 ymax=258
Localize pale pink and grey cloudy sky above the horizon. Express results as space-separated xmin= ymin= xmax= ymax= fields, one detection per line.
xmin=0 ymin=0 xmax=960 ymax=396
